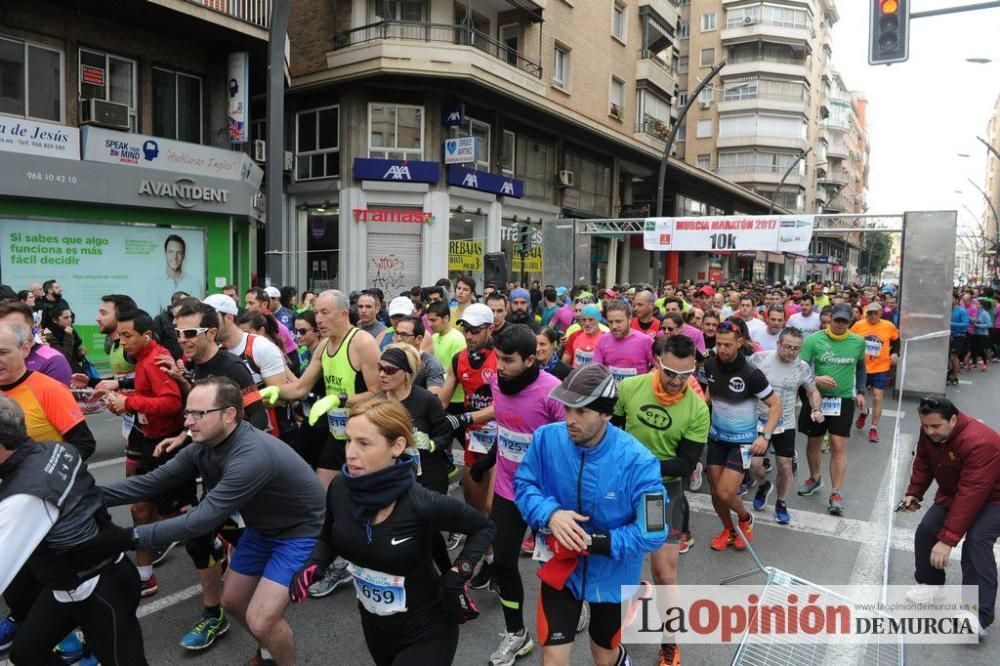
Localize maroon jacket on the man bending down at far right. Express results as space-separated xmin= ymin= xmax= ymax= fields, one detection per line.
xmin=906 ymin=414 xmax=1000 ymax=546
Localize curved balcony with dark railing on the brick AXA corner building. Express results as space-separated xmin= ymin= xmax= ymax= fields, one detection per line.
xmin=327 ymin=21 xmax=545 ymax=83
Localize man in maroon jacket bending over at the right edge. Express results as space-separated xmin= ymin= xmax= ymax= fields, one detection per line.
xmin=903 ymin=397 xmax=1000 ymax=634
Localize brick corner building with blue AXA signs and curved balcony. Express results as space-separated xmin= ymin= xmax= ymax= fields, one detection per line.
xmin=285 ymin=0 xmax=788 ymax=293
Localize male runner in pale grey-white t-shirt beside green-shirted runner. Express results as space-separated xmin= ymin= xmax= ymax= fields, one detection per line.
xmin=749 ymin=327 xmax=823 ymax=525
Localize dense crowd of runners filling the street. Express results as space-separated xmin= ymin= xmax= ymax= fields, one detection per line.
xmin=0 ymin=277 xmax=928 ymax=666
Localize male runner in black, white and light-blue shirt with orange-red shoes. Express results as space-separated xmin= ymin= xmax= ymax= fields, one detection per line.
xmin=704 ymin=322 xmax=781 ymax=550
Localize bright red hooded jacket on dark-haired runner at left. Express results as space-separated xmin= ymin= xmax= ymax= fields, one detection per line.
xmin=125 ymin=341 xmax=184 ymax=439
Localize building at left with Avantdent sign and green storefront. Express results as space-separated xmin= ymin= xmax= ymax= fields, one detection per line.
xmin=0 ymin=0 xmax=269 ymax=360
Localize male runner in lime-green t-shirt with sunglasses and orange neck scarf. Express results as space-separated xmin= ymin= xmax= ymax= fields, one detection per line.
xmin=612 ymin=335 xmax=710 ymax=666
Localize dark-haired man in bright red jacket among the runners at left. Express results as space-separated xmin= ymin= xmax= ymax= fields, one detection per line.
xmin=105 ymin=310 xmax=186 ymax=597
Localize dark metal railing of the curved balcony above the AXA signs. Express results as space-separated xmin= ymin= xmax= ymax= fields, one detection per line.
xmin=333 ymin=21 xmax=542 ymax=79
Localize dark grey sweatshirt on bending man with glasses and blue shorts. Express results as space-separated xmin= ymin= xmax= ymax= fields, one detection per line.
xmin=101 ymin=422 xmax=326 ymax=550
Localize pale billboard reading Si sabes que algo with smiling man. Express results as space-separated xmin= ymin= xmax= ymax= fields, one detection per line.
xmin=0 ymin=219 xmax=206 ymax=322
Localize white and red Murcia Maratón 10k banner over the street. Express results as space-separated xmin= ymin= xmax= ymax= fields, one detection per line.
xmin=643 ymin=215 xmax=814 ymax=254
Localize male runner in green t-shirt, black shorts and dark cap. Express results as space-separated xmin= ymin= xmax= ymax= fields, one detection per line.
xmin=799 ymin=303 xmax=867 ymax=516
